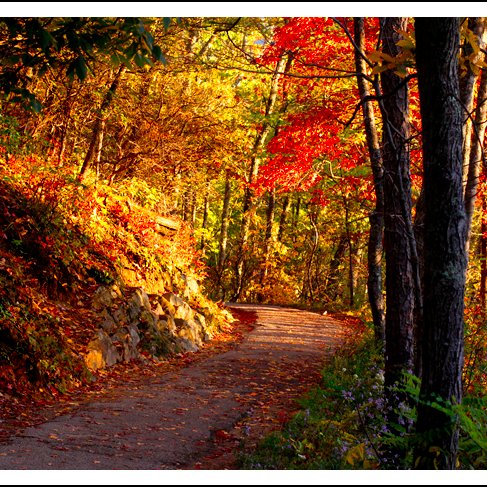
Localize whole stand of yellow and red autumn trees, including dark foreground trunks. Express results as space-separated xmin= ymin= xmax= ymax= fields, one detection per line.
xmin=0 ymin=13 xmax=487 ymax=468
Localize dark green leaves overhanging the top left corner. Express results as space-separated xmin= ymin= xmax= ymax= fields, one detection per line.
xmin=0 ymin=17 xmax=169 ymax=112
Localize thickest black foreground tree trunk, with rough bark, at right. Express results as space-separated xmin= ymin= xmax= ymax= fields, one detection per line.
xmin=416 ymin=18 xmax=467 ymax=469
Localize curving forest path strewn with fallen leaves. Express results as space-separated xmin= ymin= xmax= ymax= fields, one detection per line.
xmin=0 ymin=303 xmax=344 ymax=470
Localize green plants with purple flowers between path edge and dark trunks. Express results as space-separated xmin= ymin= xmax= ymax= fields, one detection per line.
xmin=241 ymin=338 xmax=384 ymax=470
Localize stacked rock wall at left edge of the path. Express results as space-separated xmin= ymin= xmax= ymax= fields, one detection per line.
xmin=85 ymin=285 xmax=232 ymax=370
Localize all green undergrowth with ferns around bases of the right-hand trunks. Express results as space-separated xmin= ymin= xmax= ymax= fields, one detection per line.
xmin=240 ymin=335 xmax=487 ymax=470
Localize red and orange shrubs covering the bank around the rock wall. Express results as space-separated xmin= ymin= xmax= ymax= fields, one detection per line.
xmin=0 ymin=151 xmax=219 ymax=394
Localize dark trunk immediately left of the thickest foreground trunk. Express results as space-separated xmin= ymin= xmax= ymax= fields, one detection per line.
xmin=381 ymin=17 xmax=416 ymax=388
